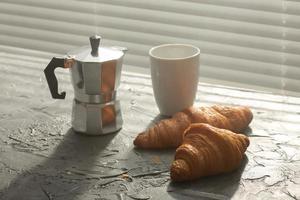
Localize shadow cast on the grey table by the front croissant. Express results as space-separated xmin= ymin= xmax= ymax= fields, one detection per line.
xmin=167 ymin=156 xmax=248 ymax=200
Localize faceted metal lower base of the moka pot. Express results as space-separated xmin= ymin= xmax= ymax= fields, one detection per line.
xmin=72 ymin=99 xmax=123 ymax=135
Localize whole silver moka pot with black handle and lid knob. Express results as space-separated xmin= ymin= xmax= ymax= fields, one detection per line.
xmin=44 ymin=36 xmax=127 ymax=135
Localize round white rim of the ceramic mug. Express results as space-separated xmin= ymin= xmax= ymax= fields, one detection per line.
xmin=149 ymin=43 xmax=200 ymax=60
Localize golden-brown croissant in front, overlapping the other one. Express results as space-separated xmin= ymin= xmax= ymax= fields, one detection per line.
xmin=170 ymin=123 xmax=249 ymax=181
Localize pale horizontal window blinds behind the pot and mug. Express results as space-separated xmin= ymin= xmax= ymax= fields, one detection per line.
xmin=0 ymin=0 xmax=300 ymax=92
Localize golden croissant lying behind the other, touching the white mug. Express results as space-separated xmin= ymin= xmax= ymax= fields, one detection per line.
xmin=133 ymin=105 xmax=253 ymax=149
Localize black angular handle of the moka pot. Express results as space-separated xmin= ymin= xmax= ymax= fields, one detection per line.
xmin=44 ymin=57 xmax=66 ymax=99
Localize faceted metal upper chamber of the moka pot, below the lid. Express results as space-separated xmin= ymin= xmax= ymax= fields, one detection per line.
xmin=70 ymin=53 xmax=123 ymax=103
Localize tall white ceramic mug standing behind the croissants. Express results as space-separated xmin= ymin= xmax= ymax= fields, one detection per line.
xmin=149 ymin=44 xmax=200 ymax=116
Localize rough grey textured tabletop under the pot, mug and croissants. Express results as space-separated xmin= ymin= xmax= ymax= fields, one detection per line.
xmin=0 ymin=49 xmax=300 ymax=200
